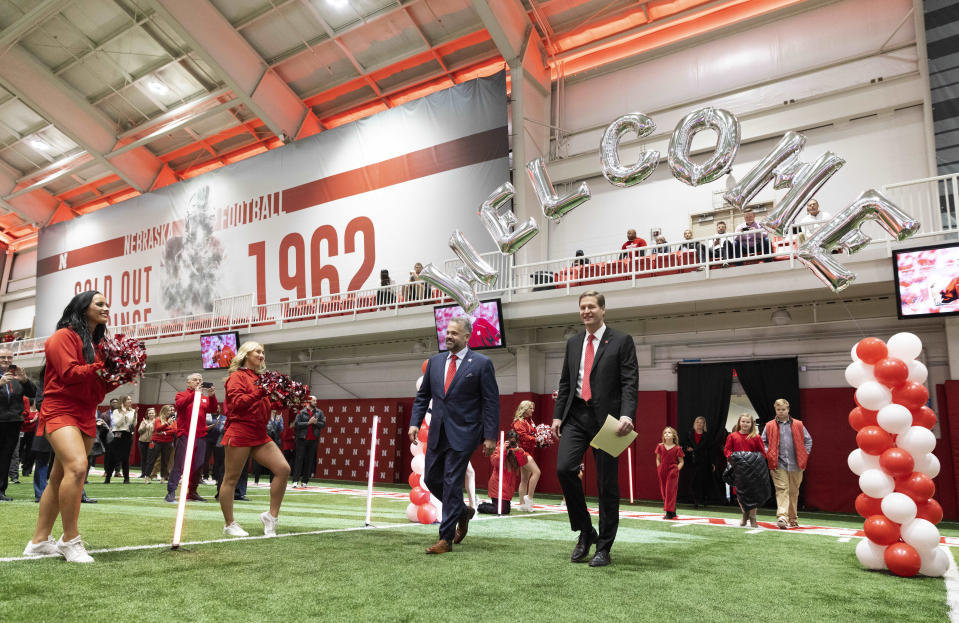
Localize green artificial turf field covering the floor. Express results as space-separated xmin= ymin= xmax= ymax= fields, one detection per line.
xmin=0 ymin=479 xmax=959 ymax=623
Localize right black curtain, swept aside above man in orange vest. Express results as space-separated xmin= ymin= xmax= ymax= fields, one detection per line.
xmin=732 ymin=357 xmax=800 ymax=432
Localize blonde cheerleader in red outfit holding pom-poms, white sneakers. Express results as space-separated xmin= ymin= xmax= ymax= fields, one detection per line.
xmin=220 ymin=342 xmax=290 ymax=536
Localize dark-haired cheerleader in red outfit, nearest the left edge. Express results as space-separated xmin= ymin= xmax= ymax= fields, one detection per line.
xmin=23 ymin=290 xmax=117 ymax=562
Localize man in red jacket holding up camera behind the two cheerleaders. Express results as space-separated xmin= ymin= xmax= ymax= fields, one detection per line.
xmin=164 ymin=373 xmax=218 ymax=503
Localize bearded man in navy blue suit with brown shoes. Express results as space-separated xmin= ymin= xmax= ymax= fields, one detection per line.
xmin=409 ymin=316 xmax=499 ymax=554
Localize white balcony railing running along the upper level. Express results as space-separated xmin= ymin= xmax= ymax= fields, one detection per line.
xmin=7 ymin=174 xmax=959 ymax=355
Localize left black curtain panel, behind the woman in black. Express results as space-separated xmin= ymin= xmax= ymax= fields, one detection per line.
xmin=676 ymin=362 xmax=733 ymax=502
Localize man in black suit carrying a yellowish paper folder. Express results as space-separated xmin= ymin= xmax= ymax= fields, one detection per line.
xmin=553 ymin=291 xmax=639 ymax=567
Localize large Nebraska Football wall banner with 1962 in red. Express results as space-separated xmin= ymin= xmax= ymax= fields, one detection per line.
xmin=36 ymin=73 xmax=509 ymax=335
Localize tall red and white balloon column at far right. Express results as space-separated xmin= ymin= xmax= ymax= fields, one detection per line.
xmin=846 ymin=333 xmax=949 ymax=577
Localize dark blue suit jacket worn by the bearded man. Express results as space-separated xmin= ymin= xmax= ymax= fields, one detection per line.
xmin=410 ymin=350 xmax=499 ymax=452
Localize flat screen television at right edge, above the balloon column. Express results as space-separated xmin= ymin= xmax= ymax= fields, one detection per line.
xmin=892 ymin=242 xmax=959 ymax=319
